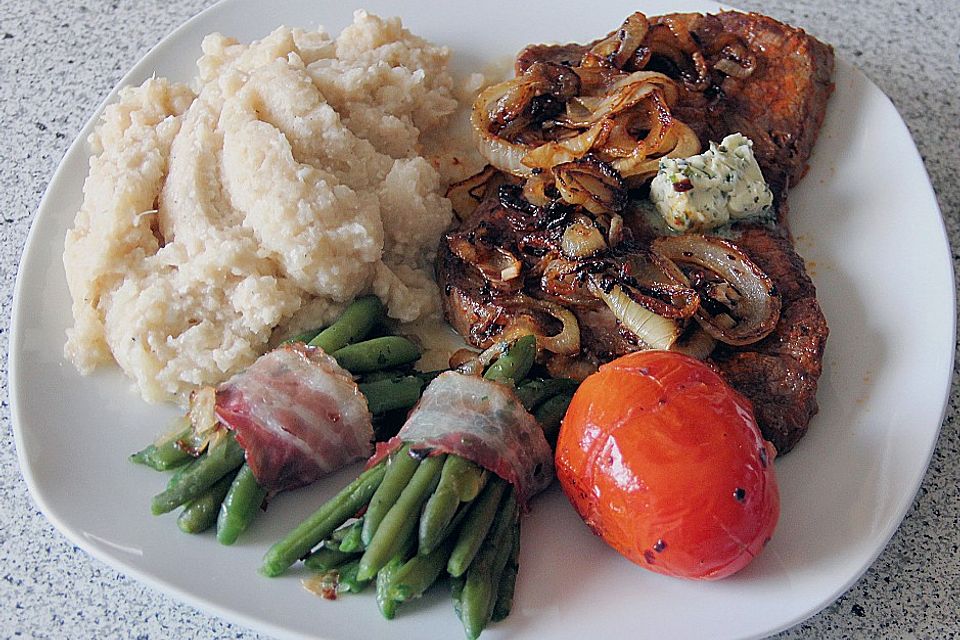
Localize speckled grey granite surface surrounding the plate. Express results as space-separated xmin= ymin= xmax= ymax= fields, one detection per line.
xmin=0 ymin=0 xmax=960 ymax=640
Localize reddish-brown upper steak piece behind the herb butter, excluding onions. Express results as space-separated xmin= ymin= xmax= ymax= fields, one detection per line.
xmin=515 ymin=11 xmax=834 ymax=196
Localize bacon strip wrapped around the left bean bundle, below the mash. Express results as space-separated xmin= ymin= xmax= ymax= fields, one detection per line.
xmin=216 ymin=344 xmax=373 ymax=494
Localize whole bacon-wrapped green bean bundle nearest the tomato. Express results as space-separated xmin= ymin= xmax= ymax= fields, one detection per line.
xmin=261 ymin=335 xmax=569 ymax=638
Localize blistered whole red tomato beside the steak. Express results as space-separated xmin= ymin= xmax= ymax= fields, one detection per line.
xmin=556 ymin=351 xmax=780 ymax=580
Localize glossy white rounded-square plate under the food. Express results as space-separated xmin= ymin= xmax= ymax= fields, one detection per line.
xmin=10 ymin=0 xmax=955 ymax=640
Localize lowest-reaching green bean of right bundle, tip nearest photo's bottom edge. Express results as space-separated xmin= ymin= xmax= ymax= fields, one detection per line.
xmin=461 ymin=489 xmax=519 ymax=640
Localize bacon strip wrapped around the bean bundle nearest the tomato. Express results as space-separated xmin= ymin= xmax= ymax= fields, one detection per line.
xmin=382 ymin=371 xmax=553 ymax=505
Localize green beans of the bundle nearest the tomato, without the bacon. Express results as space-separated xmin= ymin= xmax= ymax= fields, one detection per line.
xmin=261 ymin=336 xmax=575 ymax=639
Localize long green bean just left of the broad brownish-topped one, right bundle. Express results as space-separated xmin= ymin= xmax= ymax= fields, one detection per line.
xmin=357 ymin=455 xmax=446 ymax=580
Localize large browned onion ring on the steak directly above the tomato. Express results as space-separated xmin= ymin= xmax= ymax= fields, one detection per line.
xmin=653 ymin=234 xmax=780 ymax=346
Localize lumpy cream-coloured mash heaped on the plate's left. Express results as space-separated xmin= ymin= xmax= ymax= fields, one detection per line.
xmin=63 ymin=11 xmax=466 ymax=402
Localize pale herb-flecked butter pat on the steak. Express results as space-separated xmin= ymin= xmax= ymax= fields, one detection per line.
xmin=650 ymin=133 xmax=773 ymax=232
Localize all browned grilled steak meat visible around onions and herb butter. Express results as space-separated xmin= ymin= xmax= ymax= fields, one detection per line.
xmin=437 ymin=12 xmax=833 ymax=454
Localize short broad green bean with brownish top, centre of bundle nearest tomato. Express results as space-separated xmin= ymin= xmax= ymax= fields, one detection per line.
xmin=419 ymin=456 xmax=482 ymax=554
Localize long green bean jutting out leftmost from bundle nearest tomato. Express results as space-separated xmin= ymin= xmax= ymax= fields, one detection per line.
xmin=260 ymin=463 xmax=386 ymax=577
